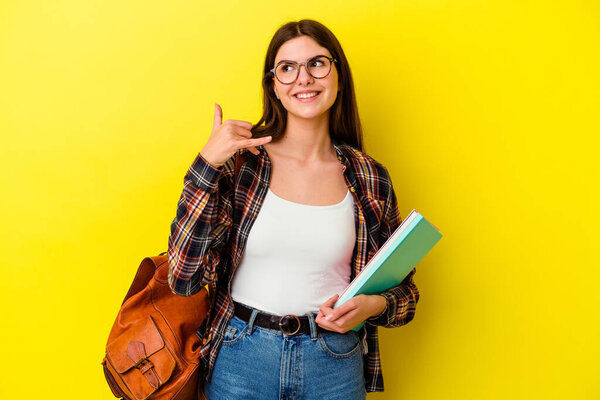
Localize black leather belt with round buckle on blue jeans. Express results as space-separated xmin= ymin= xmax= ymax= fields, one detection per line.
xmin=233 ymin=301 xmax=325 ymax=336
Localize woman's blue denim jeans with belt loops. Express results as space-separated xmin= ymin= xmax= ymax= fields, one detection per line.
xmin=204 ymin=307 xmax=367 ymax=400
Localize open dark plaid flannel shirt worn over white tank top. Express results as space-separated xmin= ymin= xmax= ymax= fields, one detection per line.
xmin=168 ymin=139 xmax=419 ymax=392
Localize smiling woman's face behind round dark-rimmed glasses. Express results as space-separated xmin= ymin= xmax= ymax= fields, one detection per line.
xmin=273 ymin=36 xmax=338 ymax=123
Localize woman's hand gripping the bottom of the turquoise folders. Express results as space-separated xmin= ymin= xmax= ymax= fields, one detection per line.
xmin=315 ymin=294 xmax=387 ymax=333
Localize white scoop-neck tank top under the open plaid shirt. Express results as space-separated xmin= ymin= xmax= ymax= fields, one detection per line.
xmin=231 ymin=188 xmax=356 ymax=315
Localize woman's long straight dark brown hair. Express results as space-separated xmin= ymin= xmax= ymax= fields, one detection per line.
xmin=252 ymin=19 xmax=362 ymax=151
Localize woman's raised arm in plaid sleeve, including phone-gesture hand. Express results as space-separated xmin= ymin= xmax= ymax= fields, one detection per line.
xmin=168 ymin=104 xmax=272 ymax=296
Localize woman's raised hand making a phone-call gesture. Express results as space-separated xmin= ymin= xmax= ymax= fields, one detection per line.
xmin=200 ymin=104 xmax=272 ymax=168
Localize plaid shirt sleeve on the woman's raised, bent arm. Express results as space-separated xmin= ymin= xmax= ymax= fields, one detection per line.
xmin=167 ymin=153 xmax=235 ymax=296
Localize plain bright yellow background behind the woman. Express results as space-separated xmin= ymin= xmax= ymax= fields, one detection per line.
xmin=0 ymin=0 xmax=600 ymax=400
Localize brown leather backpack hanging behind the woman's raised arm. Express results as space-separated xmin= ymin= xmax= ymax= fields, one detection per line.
xmin=102 ymin=154 xmax=244 ymax=400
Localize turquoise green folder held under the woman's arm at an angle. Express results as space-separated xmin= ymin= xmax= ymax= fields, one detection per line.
xmin=333 ymin=210 xmax=442 ymax=331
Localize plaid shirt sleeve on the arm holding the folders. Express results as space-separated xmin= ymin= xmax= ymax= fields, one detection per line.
xmin=366 ymin=170 xmax=419 ymax=328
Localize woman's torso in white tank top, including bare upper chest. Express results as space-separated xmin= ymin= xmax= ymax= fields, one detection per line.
xmin=231 ymin=144 xmax=356 ymax=315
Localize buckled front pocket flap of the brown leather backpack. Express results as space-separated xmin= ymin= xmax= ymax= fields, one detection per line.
xmin=106 ymin=316 xmax=175 ymax=400
